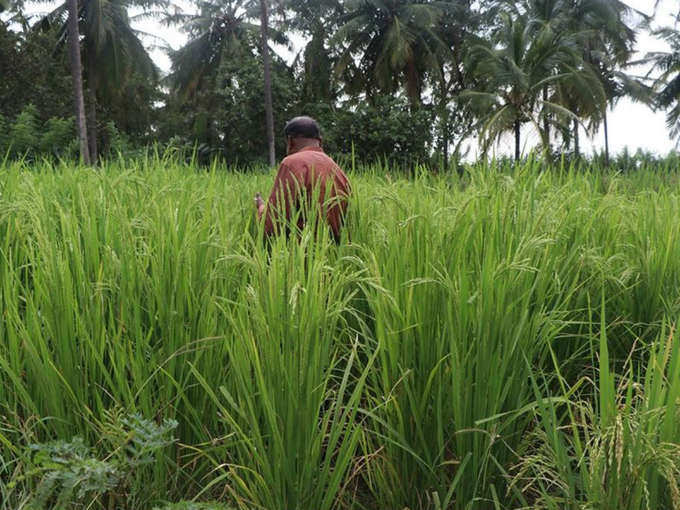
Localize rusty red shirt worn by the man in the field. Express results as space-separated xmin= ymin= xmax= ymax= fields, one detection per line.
xmin=264 ymin=147 xmax=350 ymax=241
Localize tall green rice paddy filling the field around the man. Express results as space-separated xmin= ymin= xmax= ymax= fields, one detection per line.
xmin=0 ymin=158 xmax=680 ymax=510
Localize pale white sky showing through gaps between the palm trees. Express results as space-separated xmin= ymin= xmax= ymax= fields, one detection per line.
xmin=9 ymin=0 xmax=678 ymax=156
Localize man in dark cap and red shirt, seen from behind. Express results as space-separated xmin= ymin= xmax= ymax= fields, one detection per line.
xmin=255 ymin=117 xmax=350 ymax=242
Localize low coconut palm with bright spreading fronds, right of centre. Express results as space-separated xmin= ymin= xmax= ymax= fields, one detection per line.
xmin=463 ymin=11 xmax=599 ymax=160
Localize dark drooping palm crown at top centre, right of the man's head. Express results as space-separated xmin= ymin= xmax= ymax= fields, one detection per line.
xmin=333 ymin=0 xmax=452 ymax=104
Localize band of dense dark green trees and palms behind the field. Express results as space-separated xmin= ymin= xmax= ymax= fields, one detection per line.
xmin=0 ymin=0 xmax=679 ymax=166
